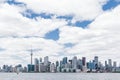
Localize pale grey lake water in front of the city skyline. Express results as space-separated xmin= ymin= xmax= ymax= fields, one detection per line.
xmin=0 ymin=73 xmax=120 ymax=80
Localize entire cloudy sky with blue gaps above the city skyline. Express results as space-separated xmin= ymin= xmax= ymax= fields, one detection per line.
xmin=0 ymin=0 xmax=120 ymax=65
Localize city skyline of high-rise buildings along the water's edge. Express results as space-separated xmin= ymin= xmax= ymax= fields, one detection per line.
xmin=0 ymin=55 xmax=120 ymax=73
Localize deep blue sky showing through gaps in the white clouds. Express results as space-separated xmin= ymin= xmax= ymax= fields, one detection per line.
xmin=7 ymin=0 xmax=120 ymax=40
